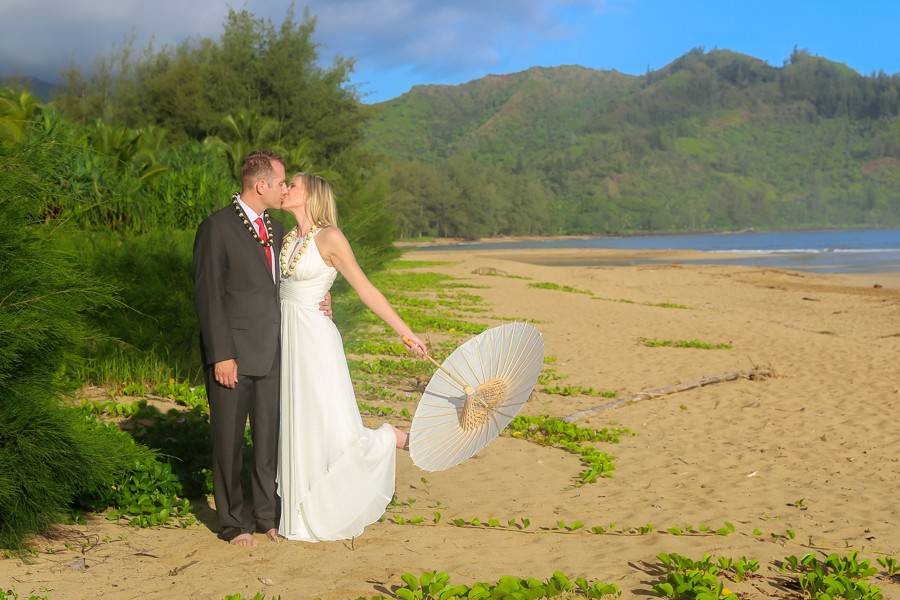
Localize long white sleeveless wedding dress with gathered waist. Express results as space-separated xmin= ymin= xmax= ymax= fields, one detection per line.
xmin=276 ymin=232 xmax=396 ymax=542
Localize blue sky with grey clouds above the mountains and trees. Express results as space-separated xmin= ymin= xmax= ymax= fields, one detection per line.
xmin=0 ymin=0 xmax=900 ymax=102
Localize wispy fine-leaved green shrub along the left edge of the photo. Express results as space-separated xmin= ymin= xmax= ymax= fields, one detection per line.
xmin=0 ymin=140 xmax=158 ymax=548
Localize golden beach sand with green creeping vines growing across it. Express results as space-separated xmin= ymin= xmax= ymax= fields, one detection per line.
xmin=0 ymin=250 xmax=900 ymax=600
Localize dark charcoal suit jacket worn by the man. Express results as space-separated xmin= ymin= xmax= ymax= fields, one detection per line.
xmin=193 ymin=204 xmax=284 ymax=376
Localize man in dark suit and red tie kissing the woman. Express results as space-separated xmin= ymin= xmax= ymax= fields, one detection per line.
xmin=193 ymin=150 xmax=331 ymax=546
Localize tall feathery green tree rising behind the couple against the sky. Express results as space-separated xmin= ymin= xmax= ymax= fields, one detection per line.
xmin=57 ymin=9 xmax=364 ymax=165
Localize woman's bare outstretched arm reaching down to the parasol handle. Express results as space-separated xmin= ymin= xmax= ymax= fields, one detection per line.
xmin=317 ymin=227 xmax=428 ymax=356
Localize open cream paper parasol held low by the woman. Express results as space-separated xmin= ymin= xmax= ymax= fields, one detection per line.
xmin=409 ymin=323 xmax=544 ymax=471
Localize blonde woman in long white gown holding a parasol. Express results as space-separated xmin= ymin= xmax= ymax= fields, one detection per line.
xmin=276 ymin=173 xmax=427 ymax=542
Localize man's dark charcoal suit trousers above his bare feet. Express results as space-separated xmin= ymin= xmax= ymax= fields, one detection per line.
xmin=206 ymin=353 xmax=281 ymax=540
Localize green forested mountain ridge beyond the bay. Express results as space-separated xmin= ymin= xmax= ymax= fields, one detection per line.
xmin=366 ymin=49 xmax=900 ymax=237
